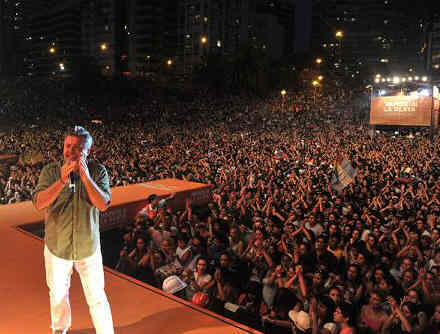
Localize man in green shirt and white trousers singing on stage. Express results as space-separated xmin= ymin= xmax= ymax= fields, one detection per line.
xmin=33 ymin=126 xmax=114 ymax=334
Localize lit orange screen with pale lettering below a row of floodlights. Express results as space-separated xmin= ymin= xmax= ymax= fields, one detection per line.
xmin=370 ymin=96 xmax=432 ymax=126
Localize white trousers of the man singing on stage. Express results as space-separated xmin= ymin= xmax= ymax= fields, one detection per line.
xmin=44 ymin=246 xmax=114 ymax=334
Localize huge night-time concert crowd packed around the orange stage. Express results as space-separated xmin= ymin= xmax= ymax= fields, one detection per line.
xmin=0 ymin=77 xmax=440 ymax=334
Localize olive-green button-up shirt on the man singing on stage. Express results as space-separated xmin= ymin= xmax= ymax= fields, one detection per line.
xmin=32 ymin=161 xmax=111 ymax=261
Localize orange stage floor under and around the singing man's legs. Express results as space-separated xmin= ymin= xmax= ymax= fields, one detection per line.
xmin=0 ymin=184 xmax=259 ymax=334
